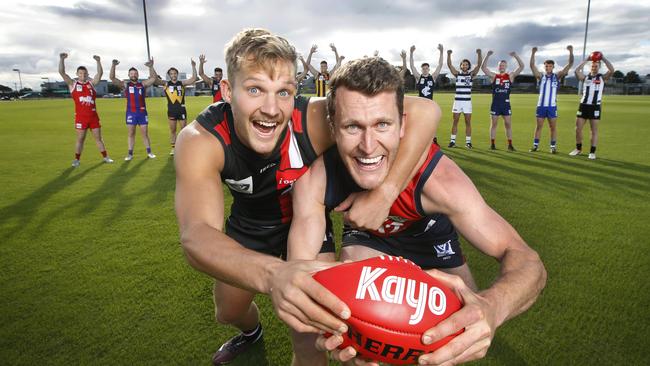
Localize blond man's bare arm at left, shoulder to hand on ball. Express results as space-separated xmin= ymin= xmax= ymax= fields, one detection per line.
xmin=174 ymin=121 xmax=349 ymax=332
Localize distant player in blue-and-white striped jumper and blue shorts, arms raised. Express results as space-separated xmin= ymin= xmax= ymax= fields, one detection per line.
xmin=530 ymin=45 xmax=573 ymax=154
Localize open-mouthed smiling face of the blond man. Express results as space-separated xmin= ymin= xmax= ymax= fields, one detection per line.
xmin=222 ymin=60 xmax=296 ymax=156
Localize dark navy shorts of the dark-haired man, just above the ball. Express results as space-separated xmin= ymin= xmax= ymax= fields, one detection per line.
xmin=341 ymin=218 xmax=465 ymax=269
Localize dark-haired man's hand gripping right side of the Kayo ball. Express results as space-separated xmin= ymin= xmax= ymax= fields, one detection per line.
xmin=418 ymin=269 xmax=497 ymax=365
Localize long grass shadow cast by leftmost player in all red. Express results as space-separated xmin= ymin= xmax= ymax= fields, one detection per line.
xmin=0 ymin=162 xmax=104 ymax=239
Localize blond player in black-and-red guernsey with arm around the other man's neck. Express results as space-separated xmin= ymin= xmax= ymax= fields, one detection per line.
xmin=175 ymin=29 xmax=436 ymax=365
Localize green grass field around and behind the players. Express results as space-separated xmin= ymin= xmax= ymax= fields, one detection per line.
xmin=0 ymin=94 xmax=650 ymax=365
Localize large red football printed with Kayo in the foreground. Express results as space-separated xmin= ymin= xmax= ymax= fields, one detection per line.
xmin=314 ymin=255 xmax=463 ymax=365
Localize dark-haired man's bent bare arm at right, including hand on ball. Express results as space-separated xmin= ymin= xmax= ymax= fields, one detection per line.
xmin=412 ymin=157 xmax=546 ymax=364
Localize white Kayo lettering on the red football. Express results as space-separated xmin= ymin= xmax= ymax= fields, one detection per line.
xmin=355 ymin=266 xmax=447 ymax=325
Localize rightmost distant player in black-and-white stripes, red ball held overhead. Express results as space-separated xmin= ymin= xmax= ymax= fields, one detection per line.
xmin=569 ymin=56 xmax=614 ymax=160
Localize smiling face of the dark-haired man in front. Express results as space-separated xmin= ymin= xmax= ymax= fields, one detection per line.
xmin=332 ymin=87 xmax=404 ymax=189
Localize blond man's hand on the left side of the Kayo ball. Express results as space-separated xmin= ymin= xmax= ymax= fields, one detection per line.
xmin=269 ymin=261 xmax=350 ymax=334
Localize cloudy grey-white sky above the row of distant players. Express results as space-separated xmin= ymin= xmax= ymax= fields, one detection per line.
xmin=0 ymin=0 xmax=650 ymax=89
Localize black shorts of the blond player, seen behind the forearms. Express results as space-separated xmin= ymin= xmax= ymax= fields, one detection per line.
xmin=226 ymin=216 xmax=336 ymax=259
